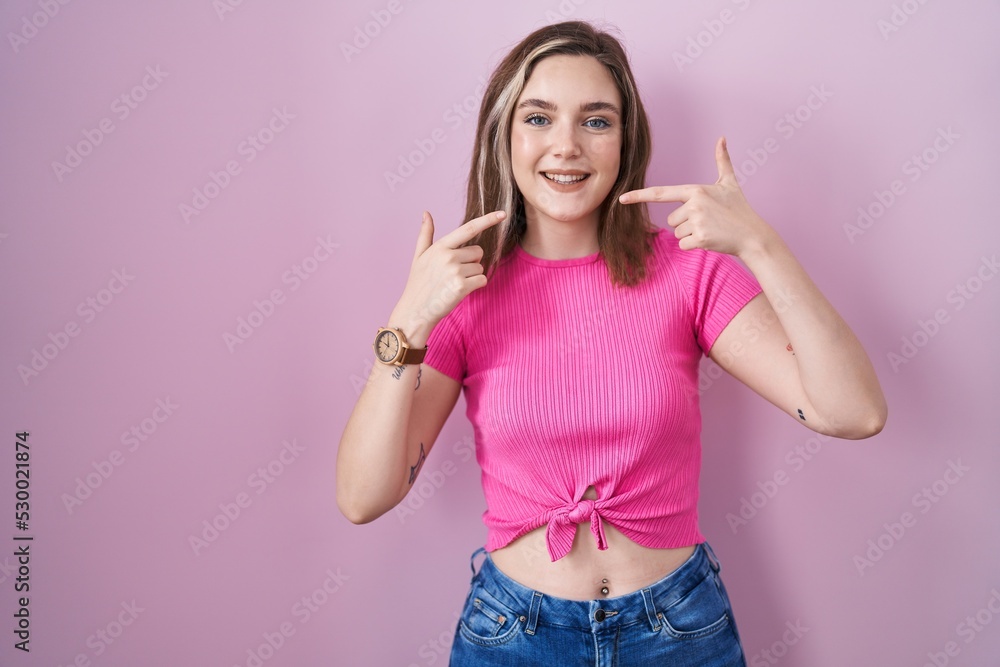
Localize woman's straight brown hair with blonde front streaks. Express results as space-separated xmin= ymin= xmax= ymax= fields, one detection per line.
xmin=465 ymin=21 xmax=653 ymax=285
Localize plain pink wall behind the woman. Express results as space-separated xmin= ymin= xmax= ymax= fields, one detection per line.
xmin=0 ymin=0 xmax=1000 ymax=667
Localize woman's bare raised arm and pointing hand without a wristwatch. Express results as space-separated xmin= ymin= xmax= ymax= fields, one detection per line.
xmin=620 ymin=138 xmax=887 ymax=439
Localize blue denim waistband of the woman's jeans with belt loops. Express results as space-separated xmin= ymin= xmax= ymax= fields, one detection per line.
xmin=472 ymin=542 xmax=721 ymax=634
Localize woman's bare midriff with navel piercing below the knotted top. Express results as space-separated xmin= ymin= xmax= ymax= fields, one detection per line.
xmin=490 ymin=486 xmax=696 ymax=600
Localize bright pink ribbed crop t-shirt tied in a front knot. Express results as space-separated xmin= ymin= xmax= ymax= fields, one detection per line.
xmin=424 ymin=229 xmax=761 ymax=561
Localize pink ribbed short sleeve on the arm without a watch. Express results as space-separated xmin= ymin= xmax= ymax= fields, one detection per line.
xmin=674 ymin=237 xmax=762 ymax=354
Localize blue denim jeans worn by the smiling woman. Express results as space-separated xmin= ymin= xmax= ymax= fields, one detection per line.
xmin=449 ymin=542 xmax=746 ymax=667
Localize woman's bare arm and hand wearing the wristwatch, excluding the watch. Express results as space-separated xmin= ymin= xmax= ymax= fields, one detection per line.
xmin=337 ymin=211 xmax=504 ymax=523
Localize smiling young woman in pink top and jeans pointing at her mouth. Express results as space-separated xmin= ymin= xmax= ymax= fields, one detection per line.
xmin=337 ymin=22 xmax=886 ymax=666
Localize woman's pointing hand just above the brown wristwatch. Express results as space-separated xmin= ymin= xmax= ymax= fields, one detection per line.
xmin=393 ymin=211 xmax=506 ymax=342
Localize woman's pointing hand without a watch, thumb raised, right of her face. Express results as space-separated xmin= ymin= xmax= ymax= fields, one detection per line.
xmin=619 ymin=137 xmax=775 ymax=257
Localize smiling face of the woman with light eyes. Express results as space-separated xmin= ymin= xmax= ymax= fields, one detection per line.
xmin=510 ymin=55 xmax=622 ymax=237
